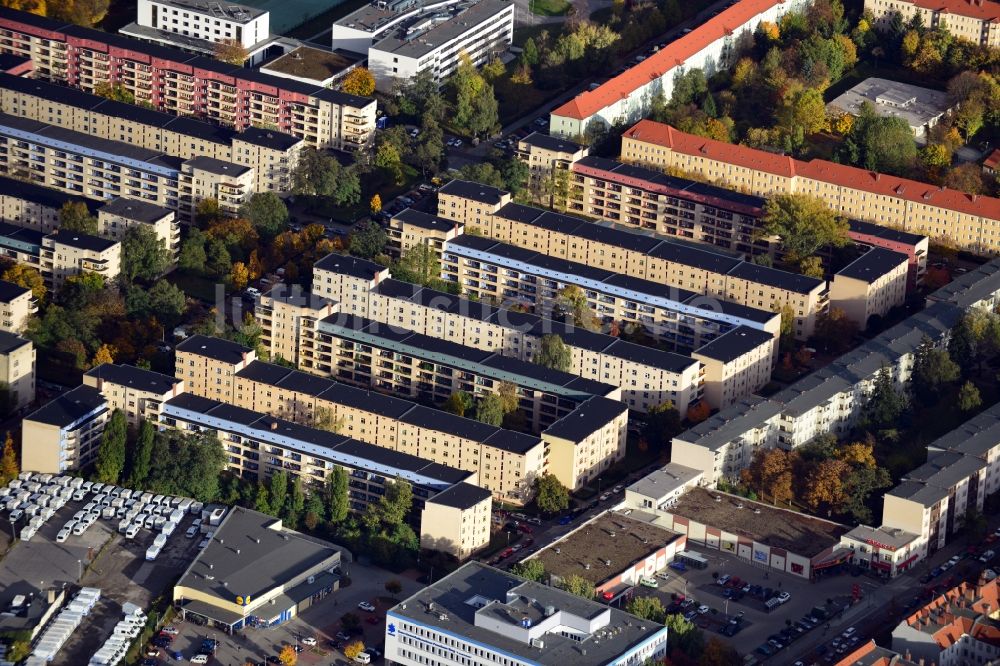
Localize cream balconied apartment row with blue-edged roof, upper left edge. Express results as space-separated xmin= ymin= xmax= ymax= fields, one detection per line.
xmin=0 ymin=113 xmax=256 ymax=220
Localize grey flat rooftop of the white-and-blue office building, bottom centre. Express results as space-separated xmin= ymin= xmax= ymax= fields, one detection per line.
xmin=387 ymin=562 xmax=666 ymax=666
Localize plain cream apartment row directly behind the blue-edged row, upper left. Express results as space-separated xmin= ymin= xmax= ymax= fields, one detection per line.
xmin=0 ymin=73 xmax=305 ymax=192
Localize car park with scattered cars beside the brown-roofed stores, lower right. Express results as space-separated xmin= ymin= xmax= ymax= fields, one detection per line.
xmin=635 ymin=548 xmax=877 ymax=664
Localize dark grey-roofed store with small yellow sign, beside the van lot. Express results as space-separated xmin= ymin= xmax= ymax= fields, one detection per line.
xmin=172 ymin=506 xmax=351 ymax=634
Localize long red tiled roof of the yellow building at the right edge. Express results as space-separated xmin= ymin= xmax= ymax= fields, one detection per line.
xmin=624 ymin=120 xmax=1000 ymax=220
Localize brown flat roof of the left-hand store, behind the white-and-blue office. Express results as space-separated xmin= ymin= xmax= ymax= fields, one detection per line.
xmin=534 ymin=512 xmax=681 ymax=585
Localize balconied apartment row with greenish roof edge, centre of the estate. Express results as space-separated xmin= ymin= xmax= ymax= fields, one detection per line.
xmin=313 ymin=315 xmax=627 ymax=432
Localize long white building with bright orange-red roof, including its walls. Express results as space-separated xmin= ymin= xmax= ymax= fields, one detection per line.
xmin=549 ymin=0 xmax=804 ymax=139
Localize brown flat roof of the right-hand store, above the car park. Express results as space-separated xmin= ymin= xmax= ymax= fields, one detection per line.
xmin=670 ymin=488 xmax=848 ymax=557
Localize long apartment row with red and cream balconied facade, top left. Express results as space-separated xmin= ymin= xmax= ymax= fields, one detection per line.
xmin=0 ymin=9 xmax=375 ymax=150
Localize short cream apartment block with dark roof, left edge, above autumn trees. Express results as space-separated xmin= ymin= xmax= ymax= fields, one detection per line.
xmin=0 ymin=222 xmax=121 ymax=290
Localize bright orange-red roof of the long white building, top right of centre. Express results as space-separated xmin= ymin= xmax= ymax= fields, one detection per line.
xmin=552 ymin=0 xmax=784 ymax=120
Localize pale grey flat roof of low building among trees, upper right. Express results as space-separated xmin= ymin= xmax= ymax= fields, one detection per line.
xmin=826 ymin=77 xmax=950 ymax=128
